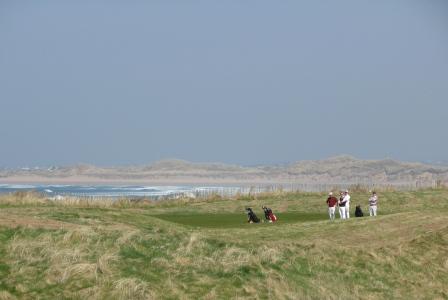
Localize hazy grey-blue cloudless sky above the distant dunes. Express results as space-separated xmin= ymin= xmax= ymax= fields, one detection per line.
xmin=0 ymin=0 xmax=448 ymax=167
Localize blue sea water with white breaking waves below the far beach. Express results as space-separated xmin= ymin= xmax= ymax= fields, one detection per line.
xmin=0 ymin=184 xmax=245 ymax=198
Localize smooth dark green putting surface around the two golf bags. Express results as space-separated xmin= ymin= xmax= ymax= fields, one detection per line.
xmin=154 ymin=212 xmax=328 ymax=228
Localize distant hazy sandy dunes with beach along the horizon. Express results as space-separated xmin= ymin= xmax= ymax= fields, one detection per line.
xmin=0 ymin=156 xmax=448 ymax=186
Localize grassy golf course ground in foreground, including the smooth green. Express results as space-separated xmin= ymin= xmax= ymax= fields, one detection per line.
xmin=0 ymin=190 xmax=448 ymax=299
